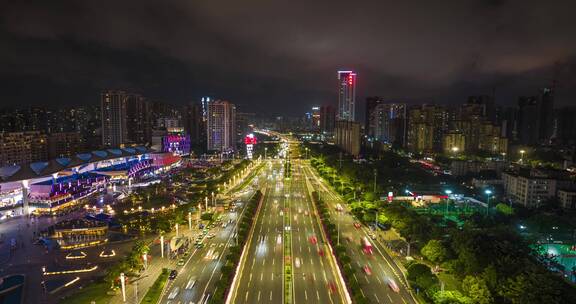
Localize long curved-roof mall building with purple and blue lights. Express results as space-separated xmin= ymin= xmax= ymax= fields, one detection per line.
xmin=0 ymin=146 xmax=181 ymax=220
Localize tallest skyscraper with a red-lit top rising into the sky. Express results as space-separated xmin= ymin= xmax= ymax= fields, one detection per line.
xmin=337 ymin=71 xmax=356 ymax=121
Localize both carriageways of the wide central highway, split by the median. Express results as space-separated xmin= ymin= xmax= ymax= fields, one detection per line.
xmin=231 ymin=162 xmax=344 ymax=303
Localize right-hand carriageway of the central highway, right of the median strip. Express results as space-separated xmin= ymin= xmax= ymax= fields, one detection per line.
xmin=291 ymin=174 xmax=341 ymax=303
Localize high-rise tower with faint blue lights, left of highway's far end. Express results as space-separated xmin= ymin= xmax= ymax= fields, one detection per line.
xmin=207 ymin=100 xmax=236 ymax=152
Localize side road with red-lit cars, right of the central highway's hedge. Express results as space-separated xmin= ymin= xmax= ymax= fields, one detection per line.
xmin=299 ymin=161 xmax=414 ymax=303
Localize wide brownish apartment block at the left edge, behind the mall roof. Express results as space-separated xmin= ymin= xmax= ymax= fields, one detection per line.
xmin=0 ymin=131 xmax=48 ymax=166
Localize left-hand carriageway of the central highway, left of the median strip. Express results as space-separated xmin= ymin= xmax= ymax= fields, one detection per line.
xmin=234 ymin=190 xmax=283 ymax=303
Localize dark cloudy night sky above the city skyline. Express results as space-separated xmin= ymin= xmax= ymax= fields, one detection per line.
xmin=0 ymin=0 xmax=576 ymax=115
